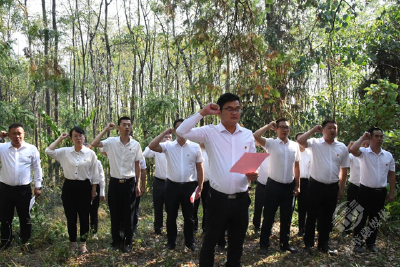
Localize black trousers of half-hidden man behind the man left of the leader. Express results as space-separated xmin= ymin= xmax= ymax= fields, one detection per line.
xmin=153 ymin=177 xmax=165 ymax=232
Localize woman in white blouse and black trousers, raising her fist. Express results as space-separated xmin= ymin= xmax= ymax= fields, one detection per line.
xmin=45 ymin=127 xmax=99 ymax=254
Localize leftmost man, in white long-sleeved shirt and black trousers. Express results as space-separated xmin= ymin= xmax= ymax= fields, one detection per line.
xmin=0 ymin=123 xmax=43 ymax=252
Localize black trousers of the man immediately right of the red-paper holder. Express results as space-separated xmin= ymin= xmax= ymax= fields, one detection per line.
xmin=260 ymin=178 xmax=296 ymax=247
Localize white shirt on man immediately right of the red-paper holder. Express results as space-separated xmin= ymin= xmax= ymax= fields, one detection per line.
xmin=263 ymin=137 xmax=300 ymax=184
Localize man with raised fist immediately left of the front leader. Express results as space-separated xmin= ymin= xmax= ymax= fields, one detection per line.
xmin=149 ymin=119 xmax=203 ymax=251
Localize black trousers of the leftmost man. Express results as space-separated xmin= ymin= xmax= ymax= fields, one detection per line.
xmin=0 ymin=182 xmax=32 ymax=245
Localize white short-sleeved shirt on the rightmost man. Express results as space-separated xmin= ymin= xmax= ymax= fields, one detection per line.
xmin=358 ymin=147 xmax=395 ymax=188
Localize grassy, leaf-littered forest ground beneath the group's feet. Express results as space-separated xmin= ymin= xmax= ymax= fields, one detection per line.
xmin=0 ymin=189 xmax=400 ymax=267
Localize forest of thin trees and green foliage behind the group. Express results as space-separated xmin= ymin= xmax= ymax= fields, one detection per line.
xmin=0 ymin=0 xmax=400 ymax=266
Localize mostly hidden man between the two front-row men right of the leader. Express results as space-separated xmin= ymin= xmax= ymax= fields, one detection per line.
xmin=295 ymin=133 xmax=311 ymax=237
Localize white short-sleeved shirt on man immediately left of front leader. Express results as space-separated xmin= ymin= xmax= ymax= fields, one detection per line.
xmin=160 ymin=140 xmax=203 ymax=183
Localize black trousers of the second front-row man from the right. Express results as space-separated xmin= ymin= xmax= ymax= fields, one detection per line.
xmin=304 ymin=178 xmax=339 ymax=249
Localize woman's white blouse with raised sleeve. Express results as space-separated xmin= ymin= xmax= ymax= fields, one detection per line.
xmin=45 ymin=146 xmax=100 ymax=184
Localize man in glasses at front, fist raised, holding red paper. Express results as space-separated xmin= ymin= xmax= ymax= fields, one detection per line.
xmin=177 ymin=93 xmax=258 ymax=266
